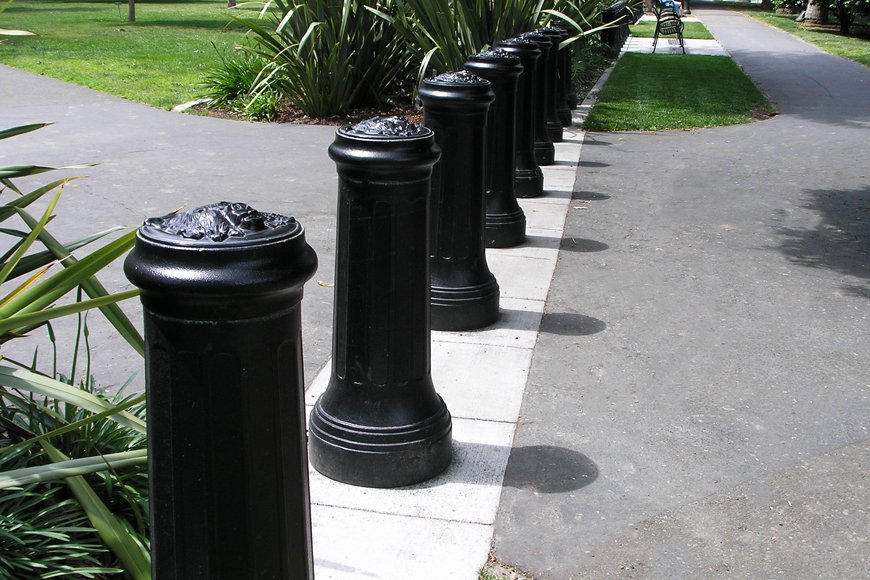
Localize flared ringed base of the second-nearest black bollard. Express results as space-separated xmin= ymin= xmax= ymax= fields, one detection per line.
xmin=308 ymin=397 xmax=453 ymax=488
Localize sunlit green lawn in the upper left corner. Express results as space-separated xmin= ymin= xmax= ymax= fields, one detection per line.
xmin=0 ymin=0 xmax=254 ymax=108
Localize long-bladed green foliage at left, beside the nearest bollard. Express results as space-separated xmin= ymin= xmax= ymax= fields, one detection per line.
xmin=0 ymin=124 xmax=150 ymax=579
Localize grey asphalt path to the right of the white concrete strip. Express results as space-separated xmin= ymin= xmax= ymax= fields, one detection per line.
xmin=494 ymin=7 xmax=870 ymax=580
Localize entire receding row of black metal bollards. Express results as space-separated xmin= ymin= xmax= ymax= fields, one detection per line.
xmin=125 ymin=19 xmax=570 ymax=579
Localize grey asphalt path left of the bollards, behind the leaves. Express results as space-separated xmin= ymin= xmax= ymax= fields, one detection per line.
xmin=0 ymin=65 xmax=338 ymax=390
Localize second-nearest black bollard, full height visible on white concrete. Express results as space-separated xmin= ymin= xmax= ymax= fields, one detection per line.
xmin=309 ymin=117 xmax=452 ymax=487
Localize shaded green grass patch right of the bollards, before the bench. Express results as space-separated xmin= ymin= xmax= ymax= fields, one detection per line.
xmin=584 ymin=53 xmax=773 ymax=131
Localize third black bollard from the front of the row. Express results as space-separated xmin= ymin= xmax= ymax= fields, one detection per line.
xmin=420 ymin=71 xmax=499 ymax=330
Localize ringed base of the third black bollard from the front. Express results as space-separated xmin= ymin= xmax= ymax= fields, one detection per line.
xmin=429 ymin=274 xmax=499 ymax=331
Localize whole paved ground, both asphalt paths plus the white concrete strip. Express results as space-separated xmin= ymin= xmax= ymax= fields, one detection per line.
xmin=0 ymin=9 xmax=870 ymax=580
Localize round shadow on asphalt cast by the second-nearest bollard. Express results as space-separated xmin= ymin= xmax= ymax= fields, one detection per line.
xmin=504 ymin=445 xmax=598 ymax=493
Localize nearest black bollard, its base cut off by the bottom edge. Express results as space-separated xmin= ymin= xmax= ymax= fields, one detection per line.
xmin=124 ymin=202 xmax=317 ymax=580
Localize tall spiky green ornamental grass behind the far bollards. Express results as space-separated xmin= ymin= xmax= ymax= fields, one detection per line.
xmin=225 ymin=0 xmax=600 ymax=117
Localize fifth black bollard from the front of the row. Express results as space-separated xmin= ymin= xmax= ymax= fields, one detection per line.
xmin=496 ymin=36 xmax=544 ymax=197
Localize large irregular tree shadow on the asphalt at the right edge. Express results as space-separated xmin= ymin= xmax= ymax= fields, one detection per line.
xmin=778 ymin=186 xmax=870 ymax=284
